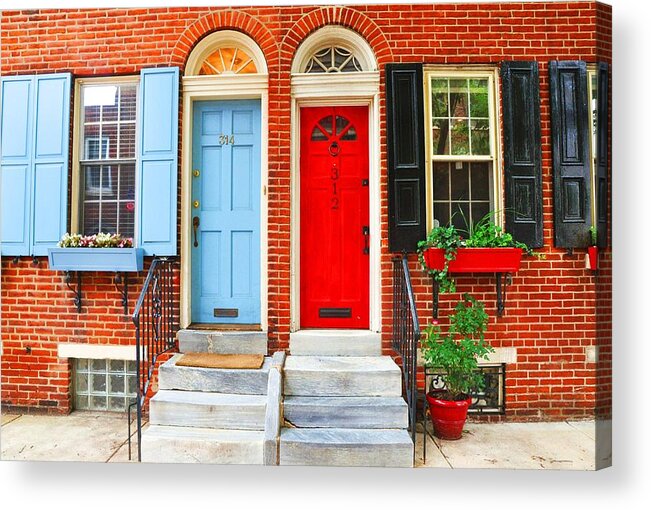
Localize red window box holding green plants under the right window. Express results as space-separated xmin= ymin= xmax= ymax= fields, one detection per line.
xmin=423 ymin=248 xmax=522 ymax=273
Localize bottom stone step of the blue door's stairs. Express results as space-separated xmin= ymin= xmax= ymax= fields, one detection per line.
xmin=142 ymin=425 xmax=264 ymax=465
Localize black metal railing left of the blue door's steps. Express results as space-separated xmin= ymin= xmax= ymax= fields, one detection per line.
xmin=128 ymin=257 xmax=178 ymax=462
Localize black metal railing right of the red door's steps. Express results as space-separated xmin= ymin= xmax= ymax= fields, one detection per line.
xmin=392 ymin=255 xmax=420 ymax=449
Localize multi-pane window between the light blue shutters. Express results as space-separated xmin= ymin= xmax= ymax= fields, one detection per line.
xmin=79 ymin=82 xmax=138 ymax=237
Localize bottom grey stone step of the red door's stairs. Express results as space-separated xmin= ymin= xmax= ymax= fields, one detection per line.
xmin=280 ymin=428 xmax=414 ymax=467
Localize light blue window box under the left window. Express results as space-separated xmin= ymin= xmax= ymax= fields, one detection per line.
xmin=48 ymin=248 xmax=143 ymax=273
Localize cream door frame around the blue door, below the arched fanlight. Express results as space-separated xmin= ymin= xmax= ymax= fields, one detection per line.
xmin=180 ymin=74 xmax=269 ymax=332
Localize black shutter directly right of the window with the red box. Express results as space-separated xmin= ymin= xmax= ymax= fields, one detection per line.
xmin=501 ymin=62 xmax=543 ymax=248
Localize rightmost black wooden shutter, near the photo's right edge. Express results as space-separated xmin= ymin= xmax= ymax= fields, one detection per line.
xmin=549 ymin=61 xmax=591 ymax=248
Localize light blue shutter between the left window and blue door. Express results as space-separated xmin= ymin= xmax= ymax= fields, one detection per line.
xmin=138 ymin=67 xmax=179 ymax=255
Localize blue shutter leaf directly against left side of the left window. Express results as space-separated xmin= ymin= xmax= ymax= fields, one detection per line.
xmin=31 ymin=74 xmax=70 ymax=255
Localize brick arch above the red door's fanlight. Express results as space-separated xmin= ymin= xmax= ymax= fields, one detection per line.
xmin=280 ymin=5 xmax=393 ymax=68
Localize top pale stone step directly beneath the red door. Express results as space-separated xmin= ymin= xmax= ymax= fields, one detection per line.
xmin=289 ymin=329 xmax=382 ymax=356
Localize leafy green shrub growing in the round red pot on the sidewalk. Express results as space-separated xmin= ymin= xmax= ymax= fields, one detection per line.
xmin=421 ymin=294 xmax=494 ymax=400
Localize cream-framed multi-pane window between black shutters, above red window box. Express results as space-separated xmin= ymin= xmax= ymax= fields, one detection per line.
xmin=426 ymin=72 xmax=496 ymax=230
